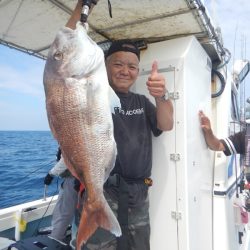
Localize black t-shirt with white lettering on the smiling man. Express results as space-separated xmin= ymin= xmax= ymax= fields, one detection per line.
xmin=112 ymin=92 xmax=162 ymax=180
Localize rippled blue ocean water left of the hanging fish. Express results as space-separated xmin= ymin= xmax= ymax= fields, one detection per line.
xmin=0 ymin=131 xmax=61 ymax=209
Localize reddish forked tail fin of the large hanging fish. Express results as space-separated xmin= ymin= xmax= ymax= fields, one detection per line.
xmin=77 ymin=196 xmax=122 ymax=250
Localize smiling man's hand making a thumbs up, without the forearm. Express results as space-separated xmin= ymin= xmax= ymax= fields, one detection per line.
xmin=147 ymin=61 xmax=167 ymax=98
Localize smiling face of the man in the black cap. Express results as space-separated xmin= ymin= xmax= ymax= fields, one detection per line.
xmin=106 ymin=51 xmax=139 ymax=93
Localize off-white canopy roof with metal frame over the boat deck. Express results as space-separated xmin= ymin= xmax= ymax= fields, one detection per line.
xmin=0 ymin=0 xmax=225 ymax=62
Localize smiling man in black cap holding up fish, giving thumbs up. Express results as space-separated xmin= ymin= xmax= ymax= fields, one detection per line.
xmin=67 ymin=1 xmax=173 ymax=250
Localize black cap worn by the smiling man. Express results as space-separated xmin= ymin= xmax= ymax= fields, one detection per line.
xmin=105 ymin=39 xmax=140 ymax=61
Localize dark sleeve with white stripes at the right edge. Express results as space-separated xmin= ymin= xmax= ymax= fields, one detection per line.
xmin=221 ymin=130 xmax=246 ymax=156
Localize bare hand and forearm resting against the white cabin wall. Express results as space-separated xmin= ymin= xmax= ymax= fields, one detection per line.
xmin=199 ymin=111 xmax=225 ymax=151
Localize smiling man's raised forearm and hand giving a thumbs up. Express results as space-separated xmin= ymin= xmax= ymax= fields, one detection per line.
xmin=147 ymin=61 xmax=174 ymax=131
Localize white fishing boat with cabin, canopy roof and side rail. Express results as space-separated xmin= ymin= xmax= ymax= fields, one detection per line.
xmin=0 ymin=0 xmax=250 ymax=250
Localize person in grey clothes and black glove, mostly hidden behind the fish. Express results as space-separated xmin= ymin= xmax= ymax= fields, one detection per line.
xmin=44 ymin=149 xmax=78 ymax=241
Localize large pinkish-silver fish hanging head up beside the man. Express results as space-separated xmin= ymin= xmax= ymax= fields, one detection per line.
xmin=44 ymin=22 xmax=121 ymax=250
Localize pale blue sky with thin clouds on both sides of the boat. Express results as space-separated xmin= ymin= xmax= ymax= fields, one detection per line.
xmin=0 ymin=0 xmax=250 ymax=130
